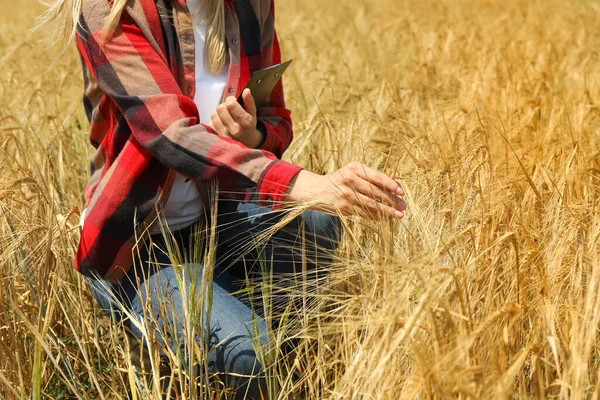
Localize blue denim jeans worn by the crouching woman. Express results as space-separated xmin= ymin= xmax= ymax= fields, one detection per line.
xmin=88 ymin=200 xmax=341 ymax=398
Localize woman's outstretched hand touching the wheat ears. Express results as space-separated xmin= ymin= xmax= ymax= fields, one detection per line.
xmin=285 ymin=162 xmax=406 ymax=219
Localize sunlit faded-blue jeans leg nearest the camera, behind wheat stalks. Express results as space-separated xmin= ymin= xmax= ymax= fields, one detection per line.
xmin=131 ymin=264 xmax=268 ymax=399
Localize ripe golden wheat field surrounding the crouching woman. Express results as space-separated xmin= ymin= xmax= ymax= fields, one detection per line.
xmin=0 ymin=0 xmax=600 ymax=399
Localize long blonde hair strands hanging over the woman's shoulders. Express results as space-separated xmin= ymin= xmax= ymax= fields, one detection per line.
xmin=36 ymin=0 xmax=227 ymax=74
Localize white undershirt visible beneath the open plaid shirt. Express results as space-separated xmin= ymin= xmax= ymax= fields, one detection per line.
xmin=153 ymin=0 xmax=229 ymax=232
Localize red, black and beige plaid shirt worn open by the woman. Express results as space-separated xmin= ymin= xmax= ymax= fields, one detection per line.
xmin=74 ymin=0 xmax=300 ymax=282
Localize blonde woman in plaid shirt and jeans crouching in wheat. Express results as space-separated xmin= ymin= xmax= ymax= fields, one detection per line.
xmin=41 ymin=0 xmax=406 ymax=396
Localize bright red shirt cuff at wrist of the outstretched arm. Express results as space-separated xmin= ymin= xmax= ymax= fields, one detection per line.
xmin=257 ymin=160 xmax=303 ymax=210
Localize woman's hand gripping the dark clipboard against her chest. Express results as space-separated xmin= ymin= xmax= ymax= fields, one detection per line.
xmin=209 ymin=89 xmax=264 ymax=149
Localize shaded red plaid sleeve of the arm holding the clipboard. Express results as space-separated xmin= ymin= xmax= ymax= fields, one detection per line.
xmin=258 ymin=0 xmax=293 ymax=158
